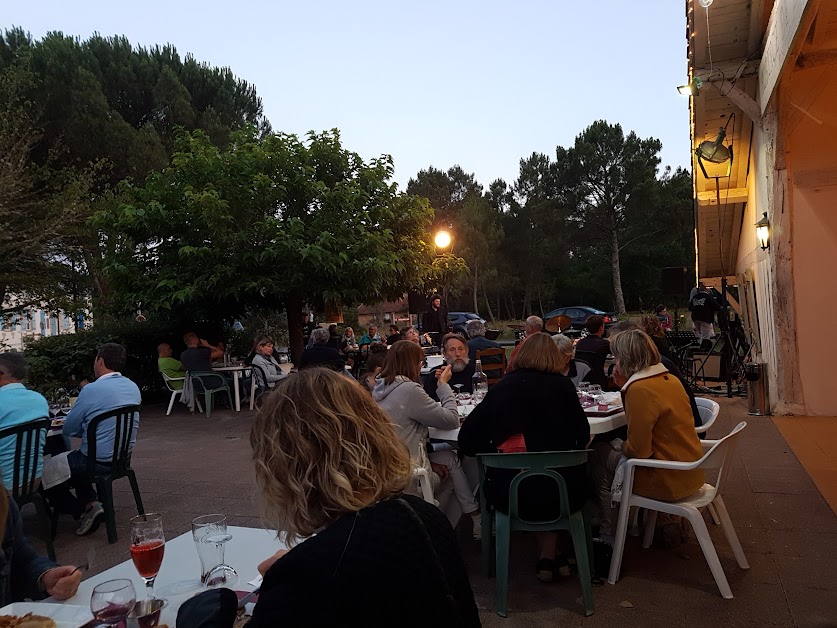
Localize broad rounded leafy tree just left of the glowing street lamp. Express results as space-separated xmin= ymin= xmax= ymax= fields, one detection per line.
xmin=95 ymin=128 xmax=433 ymax=357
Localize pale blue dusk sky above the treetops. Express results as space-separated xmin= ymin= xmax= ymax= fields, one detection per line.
xmin=0 ymin=0 xmax=689 ymax=187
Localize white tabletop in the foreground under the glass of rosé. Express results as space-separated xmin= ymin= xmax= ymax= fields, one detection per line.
xmin=46 ymin=526 xmax=285 ymax=627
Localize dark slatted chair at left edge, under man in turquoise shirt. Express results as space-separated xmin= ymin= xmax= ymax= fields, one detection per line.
xmin=0 ymin=417 xmax=55 ymax=561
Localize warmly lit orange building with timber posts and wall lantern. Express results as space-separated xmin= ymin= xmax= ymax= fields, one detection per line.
xmin=686 ymin=0 xmax=837 ymax=416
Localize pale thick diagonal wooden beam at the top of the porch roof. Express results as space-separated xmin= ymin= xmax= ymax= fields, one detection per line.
xmin=758 ymin=0 xmax=820 ymax=113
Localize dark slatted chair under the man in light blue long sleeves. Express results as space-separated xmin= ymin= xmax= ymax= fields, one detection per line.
xmin=87 ymin=406 xmax=145 ymax=543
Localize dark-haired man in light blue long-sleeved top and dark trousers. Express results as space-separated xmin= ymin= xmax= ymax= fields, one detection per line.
xmin=57 ymin=342 xmax=142 ymax=536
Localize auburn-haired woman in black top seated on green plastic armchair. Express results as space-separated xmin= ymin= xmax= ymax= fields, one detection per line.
xmin=459 ymin=333 xmax=590 ymax=580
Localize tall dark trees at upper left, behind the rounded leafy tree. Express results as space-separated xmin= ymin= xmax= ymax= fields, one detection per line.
xmin=0 ymin=28 xmax=270 ymax=308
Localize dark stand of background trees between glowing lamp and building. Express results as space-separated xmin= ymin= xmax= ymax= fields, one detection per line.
xmin=409 ymin=121 xmax=694 ymax=319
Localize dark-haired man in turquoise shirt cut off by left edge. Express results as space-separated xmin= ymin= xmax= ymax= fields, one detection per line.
xmin=0 ymin=353 xmax=49 ymax=490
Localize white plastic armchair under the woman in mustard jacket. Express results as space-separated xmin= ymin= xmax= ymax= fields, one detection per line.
xmin=607 ymin=421 xmax=750 ymax=599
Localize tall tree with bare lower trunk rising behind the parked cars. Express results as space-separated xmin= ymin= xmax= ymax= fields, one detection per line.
xmin=556 ymin=120 xmax=662 ymax=314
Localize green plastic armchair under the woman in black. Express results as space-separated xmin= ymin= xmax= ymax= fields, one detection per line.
xmin=477 ymin=450 xmax=593 ymax=617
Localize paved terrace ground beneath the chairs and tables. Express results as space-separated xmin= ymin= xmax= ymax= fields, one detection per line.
xmin=18 ymin=398 xmax=837 ymax=628
